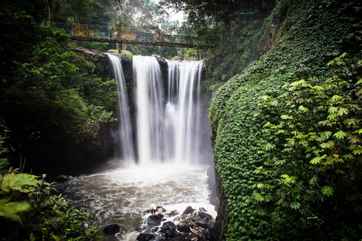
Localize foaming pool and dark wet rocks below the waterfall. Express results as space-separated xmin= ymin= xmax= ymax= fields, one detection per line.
xmin=58 ymin=164 xmax=216 ymax=241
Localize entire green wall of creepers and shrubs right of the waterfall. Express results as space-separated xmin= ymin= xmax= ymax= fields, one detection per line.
xmin=210 ymin=1 xmax=362 ymax=241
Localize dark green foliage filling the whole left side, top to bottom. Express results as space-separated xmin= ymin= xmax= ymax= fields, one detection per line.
xmin=0 ymin=0 xmax=117 ymax=241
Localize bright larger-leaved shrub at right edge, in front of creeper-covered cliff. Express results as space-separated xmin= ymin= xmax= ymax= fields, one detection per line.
xmin=253 ymin=54 xmax=362 ymax=240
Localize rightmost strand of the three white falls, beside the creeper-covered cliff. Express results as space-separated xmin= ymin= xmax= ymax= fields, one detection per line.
xmin=166 ymin=61 xmax=202 ymax=163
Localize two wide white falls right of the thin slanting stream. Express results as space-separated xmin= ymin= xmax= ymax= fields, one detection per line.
xmin=133 ymin=56 xmax=203 ymax=165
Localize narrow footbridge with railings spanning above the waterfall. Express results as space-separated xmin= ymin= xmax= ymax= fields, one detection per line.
xmin=56 ymin=23 xmax=213 ymax=49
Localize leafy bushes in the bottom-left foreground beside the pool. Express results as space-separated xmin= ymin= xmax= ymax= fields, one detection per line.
xmin=0 ymin=130 xmax=99 ymax=241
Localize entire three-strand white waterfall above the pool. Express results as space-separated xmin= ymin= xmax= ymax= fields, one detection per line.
xmin=107 ymin=54 xmax=203 ymax=166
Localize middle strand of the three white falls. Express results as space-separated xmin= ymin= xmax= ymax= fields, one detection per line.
xmin=133 ymin=56 xmax=165 ymax=164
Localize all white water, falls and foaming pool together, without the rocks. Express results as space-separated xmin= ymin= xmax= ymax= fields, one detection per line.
xmin=63 ymin=54 xmax=216 ymax=237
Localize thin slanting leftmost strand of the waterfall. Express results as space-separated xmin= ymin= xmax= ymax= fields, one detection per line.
xmin=106 ymin=53 xmax=135 ymax=163
